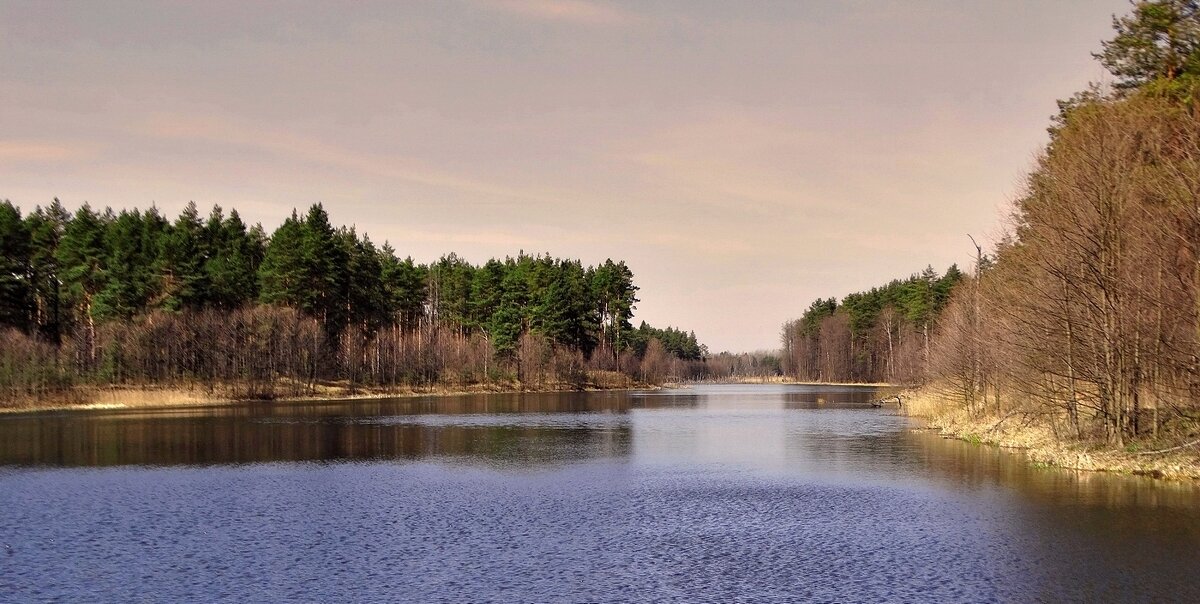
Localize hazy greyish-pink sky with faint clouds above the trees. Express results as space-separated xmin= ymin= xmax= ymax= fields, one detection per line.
xmin=0 ymin=0 xmax=1129 ymax=352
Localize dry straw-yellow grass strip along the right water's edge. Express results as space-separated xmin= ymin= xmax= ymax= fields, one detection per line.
xmin=901 ymin=389 xmax=1200 ymax=480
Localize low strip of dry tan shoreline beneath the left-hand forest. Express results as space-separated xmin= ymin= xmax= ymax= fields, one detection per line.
xmin=0 ymin=372 xmax=664 ymax=414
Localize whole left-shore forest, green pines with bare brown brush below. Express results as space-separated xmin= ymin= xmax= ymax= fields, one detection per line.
xmin=0 ymin=199 xmax=707 ymax=399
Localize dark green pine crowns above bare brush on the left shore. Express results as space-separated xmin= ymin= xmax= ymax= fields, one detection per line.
xmin=0 ymin=201 xmax=707 ymax=375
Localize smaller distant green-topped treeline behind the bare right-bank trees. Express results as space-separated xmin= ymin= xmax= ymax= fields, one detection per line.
xmin=780 ymin=267 xmax=962 ymax=383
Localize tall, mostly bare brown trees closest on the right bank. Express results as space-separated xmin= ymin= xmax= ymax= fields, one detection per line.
xmin=929 ymin=0 xmax=1200 ymax=447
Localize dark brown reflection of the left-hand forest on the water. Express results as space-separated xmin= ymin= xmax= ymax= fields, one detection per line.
xmin=0 ymin=393 xmax=630 ymax=466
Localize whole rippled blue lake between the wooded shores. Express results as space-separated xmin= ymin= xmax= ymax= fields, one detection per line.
xmin=0 ymin=385 xmax=1200 ymax=603
